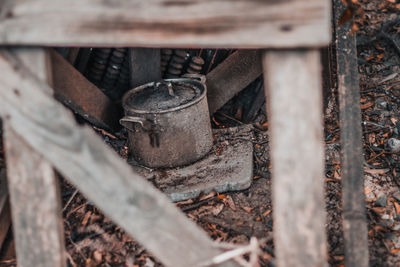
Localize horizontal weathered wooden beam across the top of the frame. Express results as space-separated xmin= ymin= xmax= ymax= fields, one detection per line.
xmin=0 ymin=0 xmax=330 ymax=48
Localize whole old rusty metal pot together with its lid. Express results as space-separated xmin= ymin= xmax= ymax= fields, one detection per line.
xmin=120 ymin=75 xmax=212 ymax=167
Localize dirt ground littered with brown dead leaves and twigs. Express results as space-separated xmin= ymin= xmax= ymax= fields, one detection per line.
xmin=0 ymin=0 xmax=400 ymax=267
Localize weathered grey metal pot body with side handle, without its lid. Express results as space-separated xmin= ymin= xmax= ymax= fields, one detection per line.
xmin=121 ymin=79 xmax=213 ymax=167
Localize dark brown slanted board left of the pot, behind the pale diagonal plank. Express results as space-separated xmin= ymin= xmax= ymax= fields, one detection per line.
xmin=50 ymin=51 xmax=121 ymax=129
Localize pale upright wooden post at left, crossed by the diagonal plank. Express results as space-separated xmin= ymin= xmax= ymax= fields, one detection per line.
xmin=4 ymin=49 xmax=66 ymax=267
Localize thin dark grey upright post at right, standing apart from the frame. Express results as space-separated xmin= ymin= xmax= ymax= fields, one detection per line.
xmin=334 ymin=0 xmax=369 ymax=267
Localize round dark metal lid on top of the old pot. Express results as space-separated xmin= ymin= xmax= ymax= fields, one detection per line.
xmin=124 ymin=79 xmax=204 ymax=112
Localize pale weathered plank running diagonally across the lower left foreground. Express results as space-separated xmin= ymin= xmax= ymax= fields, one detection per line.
xmin=0 ymin=50 xmax=236 ymax=267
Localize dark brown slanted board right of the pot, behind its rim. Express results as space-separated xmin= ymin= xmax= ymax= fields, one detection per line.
xmin=206 ymin=50 xmax=262 ymax=114
